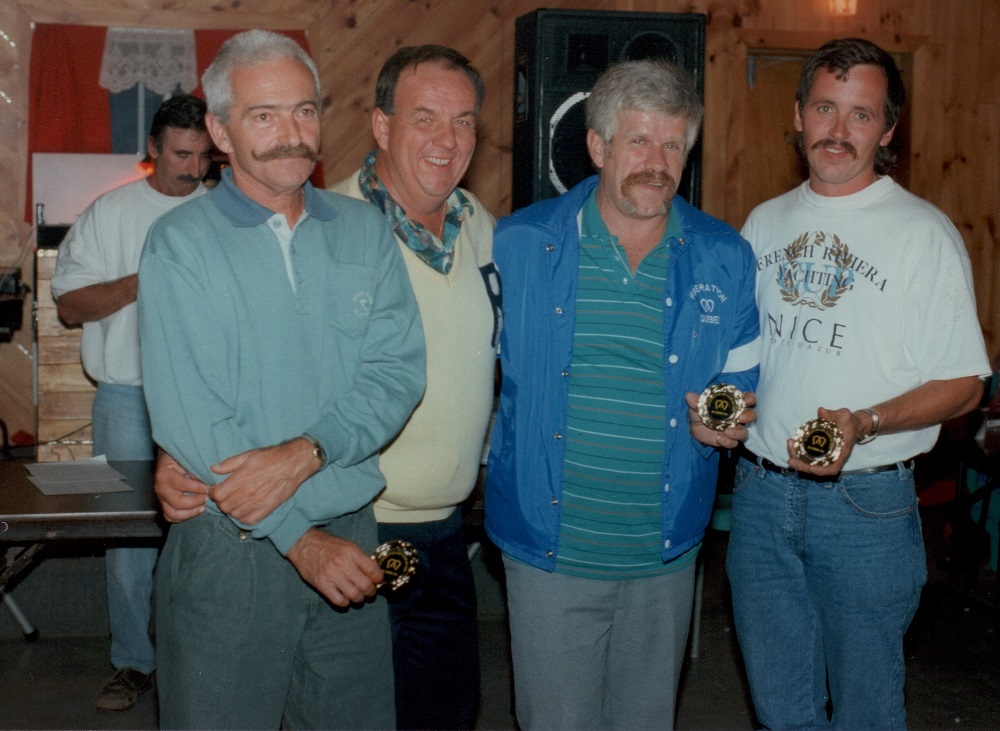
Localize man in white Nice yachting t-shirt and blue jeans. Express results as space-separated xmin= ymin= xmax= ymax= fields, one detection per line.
xmin=727 ymin=39 xmax=990 ymax=729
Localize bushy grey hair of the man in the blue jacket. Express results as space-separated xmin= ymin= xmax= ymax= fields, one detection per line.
xmin=586 ymin=59 xmax=705 ymax=155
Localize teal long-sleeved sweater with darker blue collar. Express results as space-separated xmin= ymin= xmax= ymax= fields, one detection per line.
xmin=139 ymin=171 xmax=425 ymax=554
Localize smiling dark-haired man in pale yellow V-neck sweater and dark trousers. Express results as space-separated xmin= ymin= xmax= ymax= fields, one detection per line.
xmin=157 ymin=46 xmax=500 ymax=729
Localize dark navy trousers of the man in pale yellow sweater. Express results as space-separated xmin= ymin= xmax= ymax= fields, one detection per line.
xmin=378 ymin=509 xmax=479 ymax=730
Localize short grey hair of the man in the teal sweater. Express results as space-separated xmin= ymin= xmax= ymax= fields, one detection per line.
xmin=201 ymin=30 xmax=320 ymax=124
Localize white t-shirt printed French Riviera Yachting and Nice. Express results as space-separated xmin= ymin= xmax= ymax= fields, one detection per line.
xmin=742 ymin=177 xmax=990 ymax=470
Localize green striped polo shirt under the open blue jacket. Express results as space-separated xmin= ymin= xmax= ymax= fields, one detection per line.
xmin=555 ymin=194 xmax=696 ymax=580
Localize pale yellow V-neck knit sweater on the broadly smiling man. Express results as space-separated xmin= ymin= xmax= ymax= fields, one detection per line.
xmin=330 ymin=173 xmax=496 ymax=523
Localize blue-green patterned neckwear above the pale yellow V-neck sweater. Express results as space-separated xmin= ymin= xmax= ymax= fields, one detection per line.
xmin=358 ymin=150 xmax=472 ymax=274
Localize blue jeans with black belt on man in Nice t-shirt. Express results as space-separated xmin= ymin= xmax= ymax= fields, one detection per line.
xmin=726 ymin=459 xmax=927 ymax=729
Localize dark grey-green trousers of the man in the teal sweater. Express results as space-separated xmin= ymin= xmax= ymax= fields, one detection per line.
xmin=156 ymin=506 xmax=395 ymax=729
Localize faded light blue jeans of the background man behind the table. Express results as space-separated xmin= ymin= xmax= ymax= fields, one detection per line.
xmin=92 ymin=383 xmax=157 ymax=673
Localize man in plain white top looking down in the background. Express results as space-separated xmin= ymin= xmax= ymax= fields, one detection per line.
xmin=52 ymin=94 xmax=212 ymax=711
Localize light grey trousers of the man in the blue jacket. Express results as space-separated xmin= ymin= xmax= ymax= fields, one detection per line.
xmin=504 ymin=555 xmax=695 ymax=731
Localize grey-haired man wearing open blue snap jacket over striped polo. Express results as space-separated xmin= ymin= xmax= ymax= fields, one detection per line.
xmin=486 ymin=61 xmax=759 ymax=731
